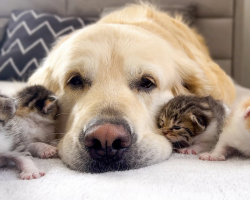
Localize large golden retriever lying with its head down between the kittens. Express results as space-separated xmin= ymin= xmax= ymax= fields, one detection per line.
xmin=29 ymin=5 xmax=235 ymax=173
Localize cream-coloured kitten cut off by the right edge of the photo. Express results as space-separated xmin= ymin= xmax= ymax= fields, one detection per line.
xmin=200 ymin=98 xmax=250 ymax=161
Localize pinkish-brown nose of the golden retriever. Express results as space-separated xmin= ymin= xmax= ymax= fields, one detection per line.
xmin=84 ymin=123 xmax=131 ymax=161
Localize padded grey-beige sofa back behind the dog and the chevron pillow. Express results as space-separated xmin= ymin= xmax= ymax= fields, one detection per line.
xmin=0 ymin=0 xmax=244 ymax=83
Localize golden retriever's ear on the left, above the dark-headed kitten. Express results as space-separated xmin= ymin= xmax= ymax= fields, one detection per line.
xmin=28 ymin=35 xmax=71 ymax=94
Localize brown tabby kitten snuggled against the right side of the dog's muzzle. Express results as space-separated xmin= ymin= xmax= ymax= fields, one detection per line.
xmin=158 ymin=95 xmax=230 ymax=154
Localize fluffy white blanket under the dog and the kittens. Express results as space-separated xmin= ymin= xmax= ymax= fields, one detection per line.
xmin=0 ymin=83 xmax=250 ymax=200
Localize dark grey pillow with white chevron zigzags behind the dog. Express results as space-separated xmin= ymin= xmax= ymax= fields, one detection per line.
xmin=0 ymin=10 xmax=84 ymax=81
